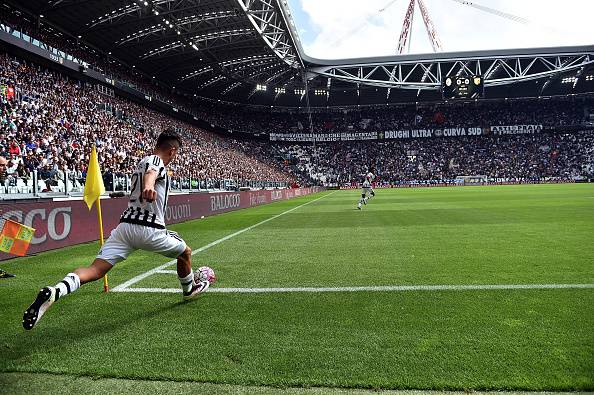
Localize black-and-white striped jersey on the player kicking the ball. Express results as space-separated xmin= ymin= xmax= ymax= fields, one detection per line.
xmin=120 ymin=155 xmax=169 ymax=229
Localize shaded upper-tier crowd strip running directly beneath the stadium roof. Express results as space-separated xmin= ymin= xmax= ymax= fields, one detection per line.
xmin=0 ymin=8 xmax=594 ymax=141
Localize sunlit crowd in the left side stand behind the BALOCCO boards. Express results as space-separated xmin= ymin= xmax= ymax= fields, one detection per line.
xmin=0 ymin=54 xmax=294 ymax=193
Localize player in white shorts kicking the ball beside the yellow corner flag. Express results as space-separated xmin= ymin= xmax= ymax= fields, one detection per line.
xmin=23 ymin=129 xmax=209 ymax=330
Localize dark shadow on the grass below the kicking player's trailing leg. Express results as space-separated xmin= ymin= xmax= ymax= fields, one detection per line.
xmin=0 ymin=301 xmax=196 ymax=368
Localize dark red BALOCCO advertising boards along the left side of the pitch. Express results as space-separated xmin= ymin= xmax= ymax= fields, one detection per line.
xmin=0 ymin=187 xmax=323 ymax=260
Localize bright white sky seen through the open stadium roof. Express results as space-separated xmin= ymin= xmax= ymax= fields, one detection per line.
xmin=288 ymin=0 xmax=594 ymax=59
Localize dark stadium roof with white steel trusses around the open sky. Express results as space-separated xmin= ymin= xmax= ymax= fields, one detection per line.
xmin=8 ymin=0 xmax=594 ymax=107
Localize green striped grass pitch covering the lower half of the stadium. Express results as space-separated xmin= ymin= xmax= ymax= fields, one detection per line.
xmin=0 ymin=184 xmax=594 ymax=393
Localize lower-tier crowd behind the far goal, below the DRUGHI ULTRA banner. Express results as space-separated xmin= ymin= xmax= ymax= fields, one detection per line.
xmin=275 ymin=130 xmax=594 ymax=185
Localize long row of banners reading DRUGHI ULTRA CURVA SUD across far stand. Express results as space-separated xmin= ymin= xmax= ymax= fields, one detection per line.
xmin=270 ymin=125 xmax=544 ymax=142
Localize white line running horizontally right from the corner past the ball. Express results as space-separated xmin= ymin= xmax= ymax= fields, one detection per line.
xmin=113 ymin=284 xmax=594 ymax=293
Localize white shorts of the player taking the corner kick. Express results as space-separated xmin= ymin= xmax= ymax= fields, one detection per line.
xmin=97 ymin=223 xmax=186 ymax=265
